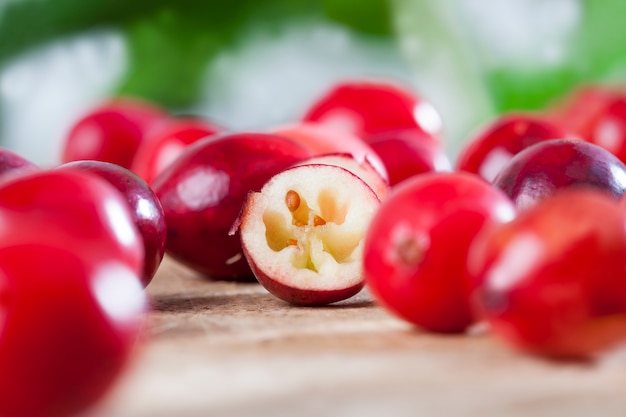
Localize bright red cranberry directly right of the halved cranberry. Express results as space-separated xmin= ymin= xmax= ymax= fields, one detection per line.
xmin=363 ymin=172 xmax=515 ymax=333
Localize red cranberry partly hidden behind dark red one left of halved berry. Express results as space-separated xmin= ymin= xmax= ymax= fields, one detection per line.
xmin=132 ymin=117 xmax=224 ymax=184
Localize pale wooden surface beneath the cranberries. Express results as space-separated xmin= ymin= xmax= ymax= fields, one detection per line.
xmin=92 ymin=259 xmax=626 ymax=417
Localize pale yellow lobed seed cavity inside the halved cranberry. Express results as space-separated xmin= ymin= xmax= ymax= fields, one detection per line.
xmin=263 ymin=188 xmax=363 ymax=272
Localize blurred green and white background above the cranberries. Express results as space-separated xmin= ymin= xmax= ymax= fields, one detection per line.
xmin=0 ymin=0 xmax=626 ymax=164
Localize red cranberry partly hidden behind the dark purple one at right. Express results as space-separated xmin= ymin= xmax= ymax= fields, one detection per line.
xmin=456 ymin=114 xmax=571 ymax=181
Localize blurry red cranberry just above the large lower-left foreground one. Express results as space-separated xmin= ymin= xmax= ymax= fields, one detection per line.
xmin=0 ymin=170 xmax=144 ymax=276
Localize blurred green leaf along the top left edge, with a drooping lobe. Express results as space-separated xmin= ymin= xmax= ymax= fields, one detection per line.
xmin=0 ymin=0 xmax=390 ymax=109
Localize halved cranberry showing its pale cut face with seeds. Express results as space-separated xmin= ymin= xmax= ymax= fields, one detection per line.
xmin=235 ymin=163 xmax=380 ymax=306
